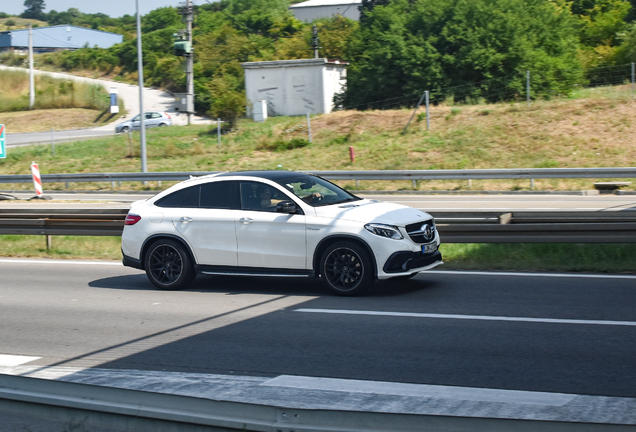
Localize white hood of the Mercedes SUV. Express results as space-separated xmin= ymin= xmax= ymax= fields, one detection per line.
xmin=315 ymin=199 xmax=433 ymax=227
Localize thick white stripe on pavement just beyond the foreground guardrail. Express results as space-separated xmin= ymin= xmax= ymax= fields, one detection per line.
xmin=261 ymin=375 xmax=576 ymax=406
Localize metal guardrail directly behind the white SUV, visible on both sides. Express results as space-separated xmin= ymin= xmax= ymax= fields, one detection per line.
xmin=0 ymin=209 xmax=636 ymax=243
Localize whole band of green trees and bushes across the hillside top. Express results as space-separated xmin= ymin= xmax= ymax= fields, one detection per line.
xmin=4 ymin=0 xmax=636 ymax=118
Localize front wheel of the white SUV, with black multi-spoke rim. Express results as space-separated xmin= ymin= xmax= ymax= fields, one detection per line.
xmin=320 ymin=241 xmax=375 ymax=296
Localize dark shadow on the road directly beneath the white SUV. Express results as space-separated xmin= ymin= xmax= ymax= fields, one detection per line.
xmin=88 ymin=273 xmax=432 ymax=297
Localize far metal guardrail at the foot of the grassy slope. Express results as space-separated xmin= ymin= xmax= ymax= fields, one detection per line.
xmin=0 ymin=167 xmax=636 ymax=184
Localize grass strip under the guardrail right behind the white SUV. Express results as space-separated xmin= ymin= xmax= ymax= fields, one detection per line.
xmin=0 ymin=235 xmax=636 ymax=274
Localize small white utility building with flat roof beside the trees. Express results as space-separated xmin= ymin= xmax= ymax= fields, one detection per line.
xmin=241 ymin=58 xmax=348 ymax=117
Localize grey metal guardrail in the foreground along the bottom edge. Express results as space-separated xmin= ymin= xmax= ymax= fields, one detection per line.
xmin=0 ymin=375 xmax=636 ymax=432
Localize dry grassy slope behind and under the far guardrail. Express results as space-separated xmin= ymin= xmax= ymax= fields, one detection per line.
xmin=0 ymin=93 xmax=636 ymax=191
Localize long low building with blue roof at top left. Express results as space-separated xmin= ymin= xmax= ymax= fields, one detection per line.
xmin=0 ymin=25 xmax=124 ymax=53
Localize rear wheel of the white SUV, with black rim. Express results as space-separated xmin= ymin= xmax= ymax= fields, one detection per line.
xmin=145 ymin=239 xmax=196 ymax=290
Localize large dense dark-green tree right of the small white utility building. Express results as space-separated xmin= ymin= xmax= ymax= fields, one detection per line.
xmin=345 ymin=0 xmax=580 ymax=106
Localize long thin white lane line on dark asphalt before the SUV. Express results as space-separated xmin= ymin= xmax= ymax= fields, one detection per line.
xmin=294 ymin=308 xmax=636 ymax=327
